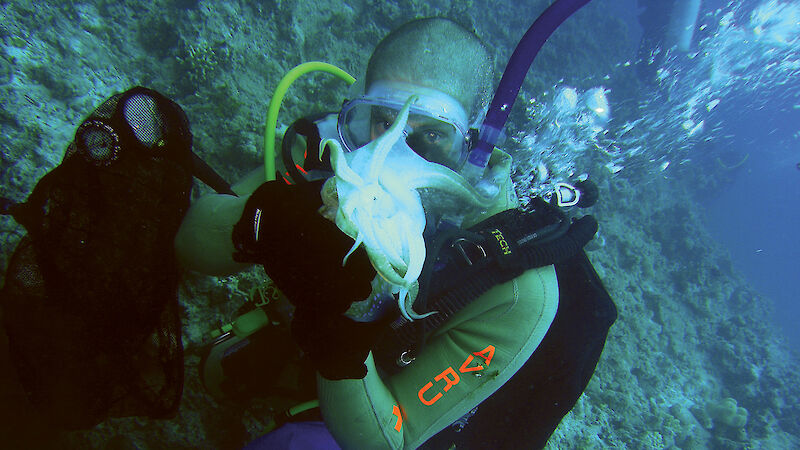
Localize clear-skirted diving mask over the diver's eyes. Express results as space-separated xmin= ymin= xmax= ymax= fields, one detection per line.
xmin=338 ymin=82 xmax=469 ymax=171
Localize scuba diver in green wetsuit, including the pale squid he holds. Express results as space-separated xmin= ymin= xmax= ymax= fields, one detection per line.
xmin=175 ymin=10 xmax=616 ymax=448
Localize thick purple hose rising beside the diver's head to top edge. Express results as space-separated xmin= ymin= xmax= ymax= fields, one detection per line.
xmin=468 ymin=0 xmax=590 ymax=168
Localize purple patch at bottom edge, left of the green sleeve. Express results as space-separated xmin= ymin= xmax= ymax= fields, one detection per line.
xmin=242 ymin=422 xmax=341 ymax=450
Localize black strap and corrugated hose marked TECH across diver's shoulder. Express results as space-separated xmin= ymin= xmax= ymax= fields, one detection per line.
xmin=373 ymin=198 xmax=597 ymax=373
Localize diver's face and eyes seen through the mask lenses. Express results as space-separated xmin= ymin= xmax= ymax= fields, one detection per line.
xmin=370 ymin=107 xmax=463 ymax=168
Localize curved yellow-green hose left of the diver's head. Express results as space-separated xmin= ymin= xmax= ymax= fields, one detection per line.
xmin=264 ymin=61 xmax=356 ymax=181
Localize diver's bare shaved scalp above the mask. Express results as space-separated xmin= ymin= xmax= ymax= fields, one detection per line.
xmin=366 ymin=17 xmax=492 ymax=120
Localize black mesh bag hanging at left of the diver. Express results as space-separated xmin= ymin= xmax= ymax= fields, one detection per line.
xmin=0 ymin=88 xmax=191 ymax=428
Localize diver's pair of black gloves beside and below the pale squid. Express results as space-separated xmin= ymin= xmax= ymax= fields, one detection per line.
xmin=233 ymin=181 xmax=385 ymax=380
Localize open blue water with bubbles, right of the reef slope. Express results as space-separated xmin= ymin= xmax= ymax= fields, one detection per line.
xmin=612 ymin=0 xmax=800 ymax=349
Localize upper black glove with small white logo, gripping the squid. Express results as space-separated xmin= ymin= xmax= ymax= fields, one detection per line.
xmin=233 ymin=181 xmax=375 ymax=314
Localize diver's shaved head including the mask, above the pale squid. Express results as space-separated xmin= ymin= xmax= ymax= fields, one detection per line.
xmin=339 ymin=18 xmax=492 ymax=171
